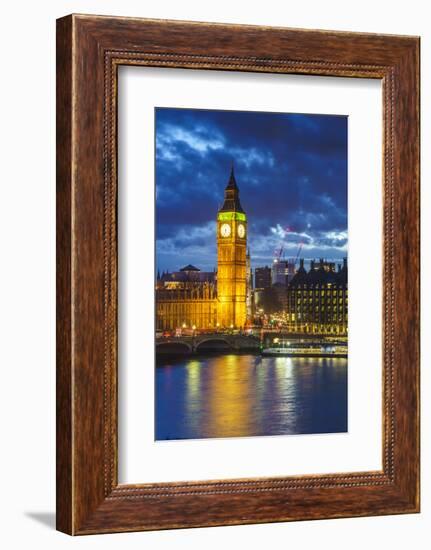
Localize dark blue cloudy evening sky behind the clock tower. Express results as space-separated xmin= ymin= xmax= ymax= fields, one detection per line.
xmin=156 ymin=108 xmax=347 ymax=271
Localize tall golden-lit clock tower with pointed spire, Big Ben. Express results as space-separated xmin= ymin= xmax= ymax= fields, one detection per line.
xmin=217 ymin=166 xmax=247 ymax=328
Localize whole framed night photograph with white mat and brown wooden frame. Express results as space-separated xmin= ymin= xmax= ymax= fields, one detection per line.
xmin=57 ymin=15 xmax=419 ymax=535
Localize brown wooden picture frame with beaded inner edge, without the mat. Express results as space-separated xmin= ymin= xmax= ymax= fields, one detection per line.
xmin=57 ymin=15 xmax=419 ymax=535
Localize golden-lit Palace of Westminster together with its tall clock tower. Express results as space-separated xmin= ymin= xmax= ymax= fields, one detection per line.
xmin=156 ymin=167 xmax=252 ymax=330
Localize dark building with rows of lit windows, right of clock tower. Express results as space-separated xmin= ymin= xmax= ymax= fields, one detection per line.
xmin=287 ymin=259 xmax=348 ymax=336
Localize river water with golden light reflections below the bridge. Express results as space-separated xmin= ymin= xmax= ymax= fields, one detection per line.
xmin=155 ymin=354 xmax=347 ymax=440
